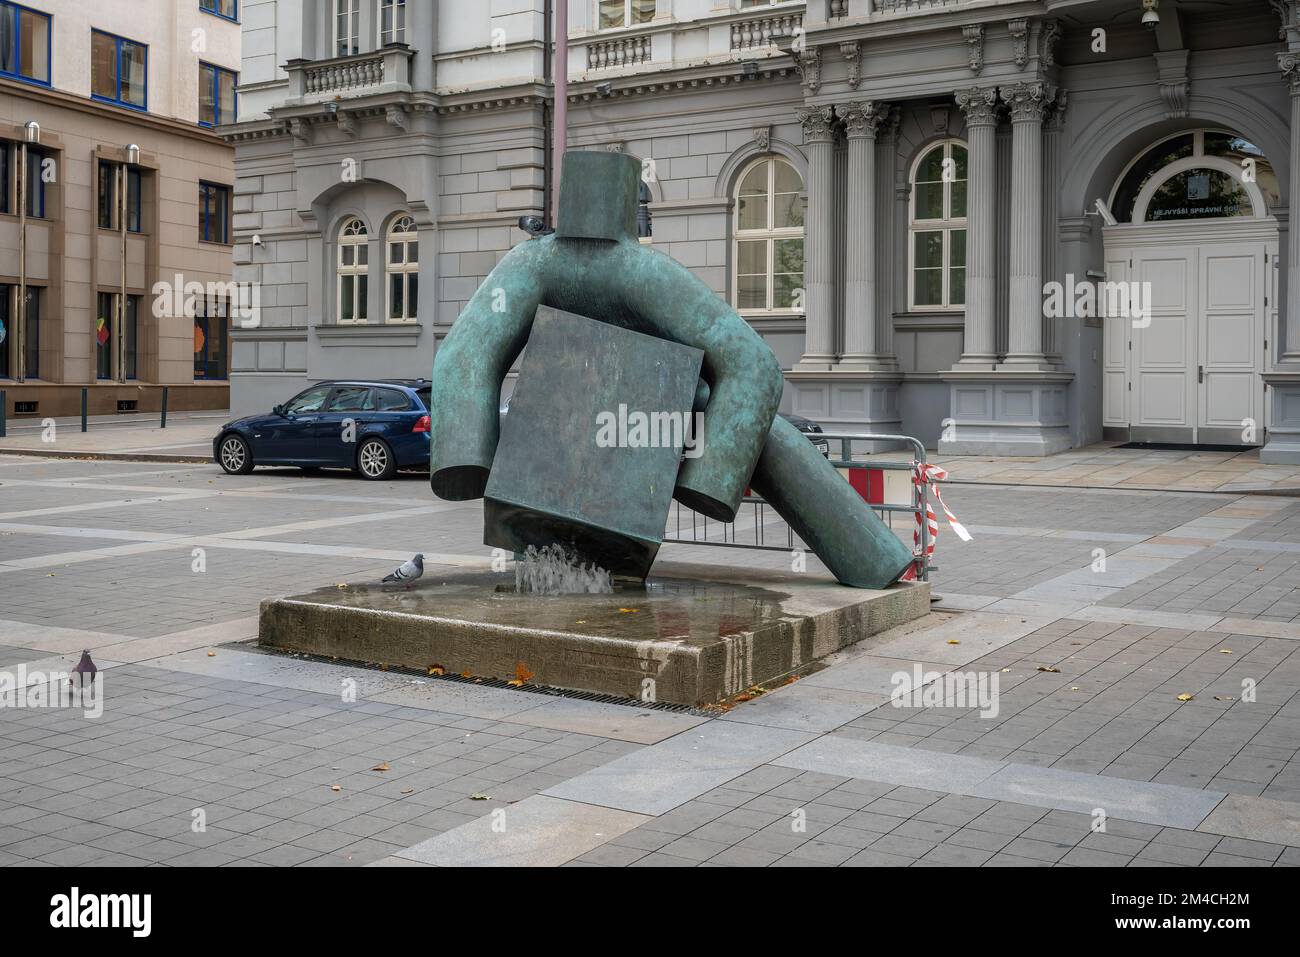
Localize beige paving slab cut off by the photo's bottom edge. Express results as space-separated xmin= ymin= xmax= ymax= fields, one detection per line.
xmin=395 ymin=794 xmax=650 ymax=867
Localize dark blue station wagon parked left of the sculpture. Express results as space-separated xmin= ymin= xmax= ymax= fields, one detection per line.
xmin=212 ymin=380 xmax=429 ymax=480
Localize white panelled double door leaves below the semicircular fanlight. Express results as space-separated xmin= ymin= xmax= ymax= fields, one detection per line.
xmin=1102 ymin=220 xmax=1278 ymax=445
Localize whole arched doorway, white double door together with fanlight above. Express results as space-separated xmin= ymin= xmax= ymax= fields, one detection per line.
xmin=1099 ymin=130 xmax=1279 ymax=446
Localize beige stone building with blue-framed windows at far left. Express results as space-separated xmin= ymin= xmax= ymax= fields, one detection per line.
xmin=0 ymin=0 xmax=242 ymax=417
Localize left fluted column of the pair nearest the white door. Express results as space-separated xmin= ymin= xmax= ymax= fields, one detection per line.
xmin=951 ymin=87 xmax=997 ymax=371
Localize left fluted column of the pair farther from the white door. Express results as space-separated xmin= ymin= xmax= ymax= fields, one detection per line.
xmin=796 ymin=107 xmax=835 ymax=371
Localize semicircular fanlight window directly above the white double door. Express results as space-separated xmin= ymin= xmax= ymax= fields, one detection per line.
xmin=1110 ymin=130 xmax=1281 ymax=222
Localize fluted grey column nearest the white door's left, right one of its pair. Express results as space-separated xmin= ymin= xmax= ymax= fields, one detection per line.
xmin=1002 ymin=83 xmax=1056 ymax=369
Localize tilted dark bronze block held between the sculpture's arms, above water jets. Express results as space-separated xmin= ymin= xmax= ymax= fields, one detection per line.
xmin=484 ymin=306 xmax=703 ymax=579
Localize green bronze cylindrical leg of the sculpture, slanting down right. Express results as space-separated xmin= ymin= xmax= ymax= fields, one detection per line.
xmin=750 ymin=416 xmax=913 ymax=588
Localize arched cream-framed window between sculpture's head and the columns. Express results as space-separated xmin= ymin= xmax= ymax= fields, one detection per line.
xmin=732 ymin=156 xmax=803 ymax=315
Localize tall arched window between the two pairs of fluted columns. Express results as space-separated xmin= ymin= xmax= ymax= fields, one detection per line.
xmin=907 ymin=139 xmax=967 ymax=309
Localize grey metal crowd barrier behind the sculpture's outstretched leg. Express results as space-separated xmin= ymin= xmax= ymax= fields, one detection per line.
xmin=663 ymin=432 xmax=932 ymax=581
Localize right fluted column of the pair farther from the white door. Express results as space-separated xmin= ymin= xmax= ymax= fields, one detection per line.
xmin=840 ymin=103 xmax=889 ymax=369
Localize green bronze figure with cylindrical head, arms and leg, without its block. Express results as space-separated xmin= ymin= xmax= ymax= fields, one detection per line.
xmin=430 ymin=152 xmax=911 ymax=588
